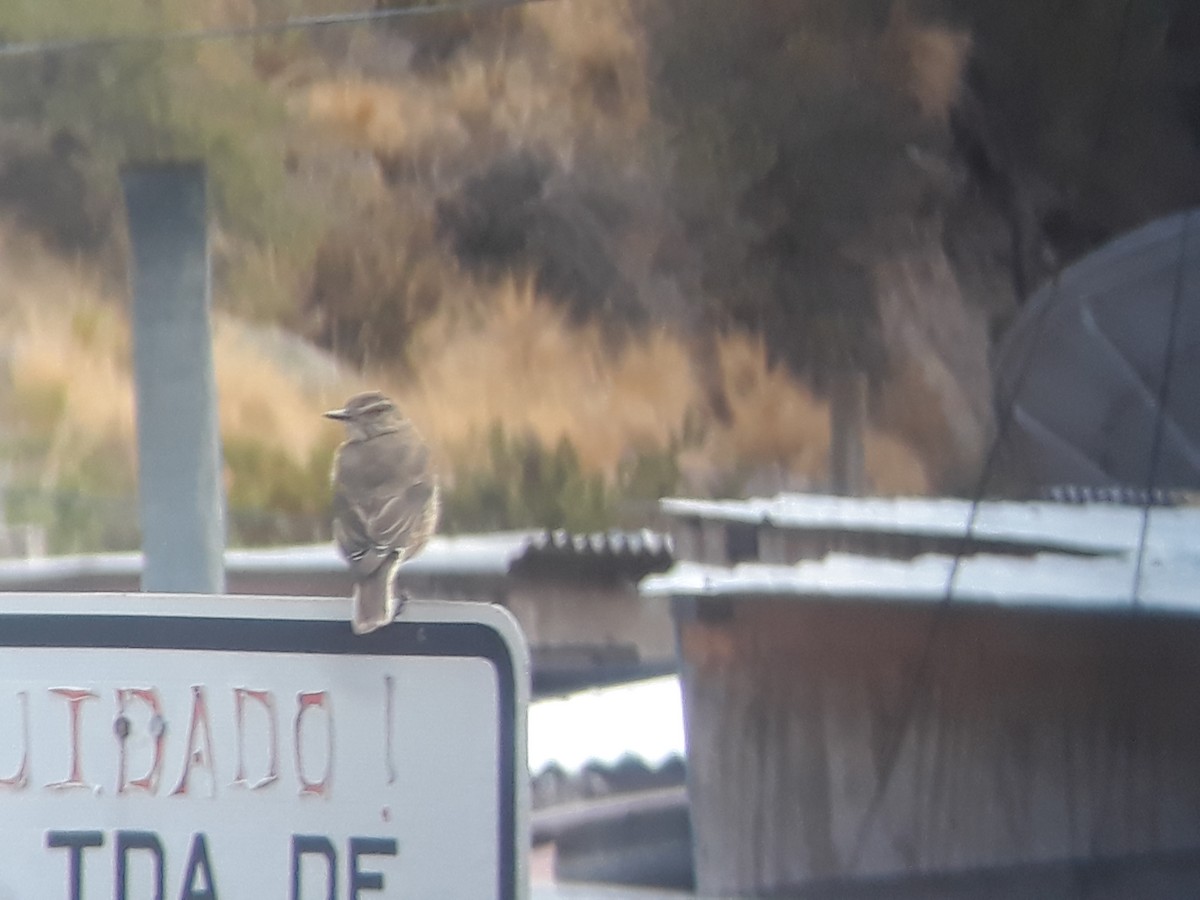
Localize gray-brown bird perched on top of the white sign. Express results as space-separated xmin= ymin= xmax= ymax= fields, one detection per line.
xmin=325 ymin=391 xmax=439 ymax=635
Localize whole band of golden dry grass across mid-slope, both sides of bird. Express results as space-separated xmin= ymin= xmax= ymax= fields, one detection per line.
xmin=2 ymin=236 xmax=925 ymax=535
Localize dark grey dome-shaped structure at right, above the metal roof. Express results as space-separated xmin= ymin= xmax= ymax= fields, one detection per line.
xmin=995 ymin=209 xmax=1200 ymax=490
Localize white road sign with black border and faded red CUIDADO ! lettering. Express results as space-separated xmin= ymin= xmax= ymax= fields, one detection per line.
xmin=0 ymin=594 xmax=529 ymax=900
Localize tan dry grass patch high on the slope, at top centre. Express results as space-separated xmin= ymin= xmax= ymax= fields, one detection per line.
xmin=292 ymin=0 xmax=650 ymax=176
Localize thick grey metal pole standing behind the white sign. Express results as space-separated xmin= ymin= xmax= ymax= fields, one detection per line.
xmin=121 ymin=163 xmax=224 ymax=593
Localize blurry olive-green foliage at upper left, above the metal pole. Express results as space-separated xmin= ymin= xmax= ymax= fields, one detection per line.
xmin=0 ymin=0 xmax=306 ymax=256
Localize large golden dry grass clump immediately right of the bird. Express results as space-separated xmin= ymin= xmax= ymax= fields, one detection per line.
xmin=400 ymin=282 xmax=696 ymax=475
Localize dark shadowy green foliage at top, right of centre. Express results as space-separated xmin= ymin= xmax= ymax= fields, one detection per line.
xmin=647 ymin=0 xmax=946 ymax=384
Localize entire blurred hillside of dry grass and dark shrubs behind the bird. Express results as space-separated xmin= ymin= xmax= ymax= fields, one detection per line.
xmin=0 ymin=0 xmax=1200 ymax=547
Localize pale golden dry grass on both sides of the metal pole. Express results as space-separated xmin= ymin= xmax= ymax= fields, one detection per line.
xmin=0 ymin=224 xmax=361 ymax=494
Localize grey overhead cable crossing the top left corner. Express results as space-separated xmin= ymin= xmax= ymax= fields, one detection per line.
xmin=0 ymin=0 xmax=551 ymax=59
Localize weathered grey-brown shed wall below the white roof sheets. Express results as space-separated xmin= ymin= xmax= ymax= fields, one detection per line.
xmin=679 ymin=601 xmax=1200 ymax=896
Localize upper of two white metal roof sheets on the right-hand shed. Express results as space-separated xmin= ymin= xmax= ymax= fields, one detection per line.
xmin=661 ymin=494 xmax=1200 ymax=554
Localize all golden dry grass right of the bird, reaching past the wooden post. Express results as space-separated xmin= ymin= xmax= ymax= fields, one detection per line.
xmin=397 ymin=282 xmax=929 ymax=493
